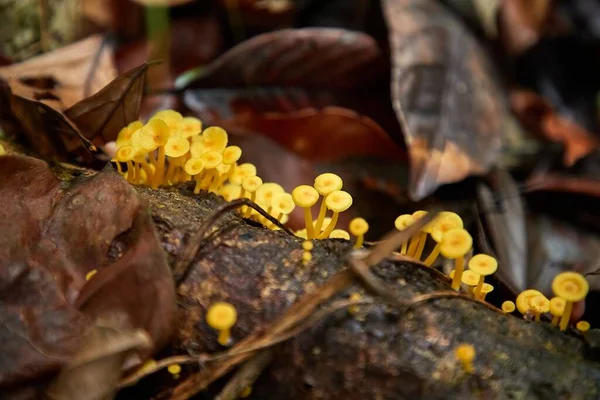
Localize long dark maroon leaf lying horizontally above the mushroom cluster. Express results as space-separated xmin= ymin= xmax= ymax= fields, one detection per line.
xmin=176 ymin=28 xmax=385 ymax=88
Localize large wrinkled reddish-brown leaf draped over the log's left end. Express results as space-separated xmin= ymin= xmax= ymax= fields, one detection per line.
xmin=0 ymin=155 xmax=175 ymax=391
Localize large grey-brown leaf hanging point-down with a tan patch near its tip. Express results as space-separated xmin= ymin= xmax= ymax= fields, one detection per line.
xmin=382 ymin=0 xmax=508 ymax=200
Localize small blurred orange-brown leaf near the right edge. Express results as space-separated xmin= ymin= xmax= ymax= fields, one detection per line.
xmin=510 ymin=90 xmax=600 ymax=166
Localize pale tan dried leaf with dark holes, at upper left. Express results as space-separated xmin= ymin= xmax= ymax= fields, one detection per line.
xmin=0 ymin=35 xmax=117 ymax=111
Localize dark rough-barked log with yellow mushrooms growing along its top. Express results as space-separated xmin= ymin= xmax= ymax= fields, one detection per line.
xmin=138 ymin=187 xmax=600 ymax=399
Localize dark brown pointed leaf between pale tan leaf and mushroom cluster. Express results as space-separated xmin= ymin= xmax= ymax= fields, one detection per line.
xmin=65 ymin=63 xmax=149 ymax=143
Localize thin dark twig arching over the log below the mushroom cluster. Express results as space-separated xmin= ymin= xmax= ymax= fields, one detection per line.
xmin=173 ymin=199 xmax=293 ymax=286
